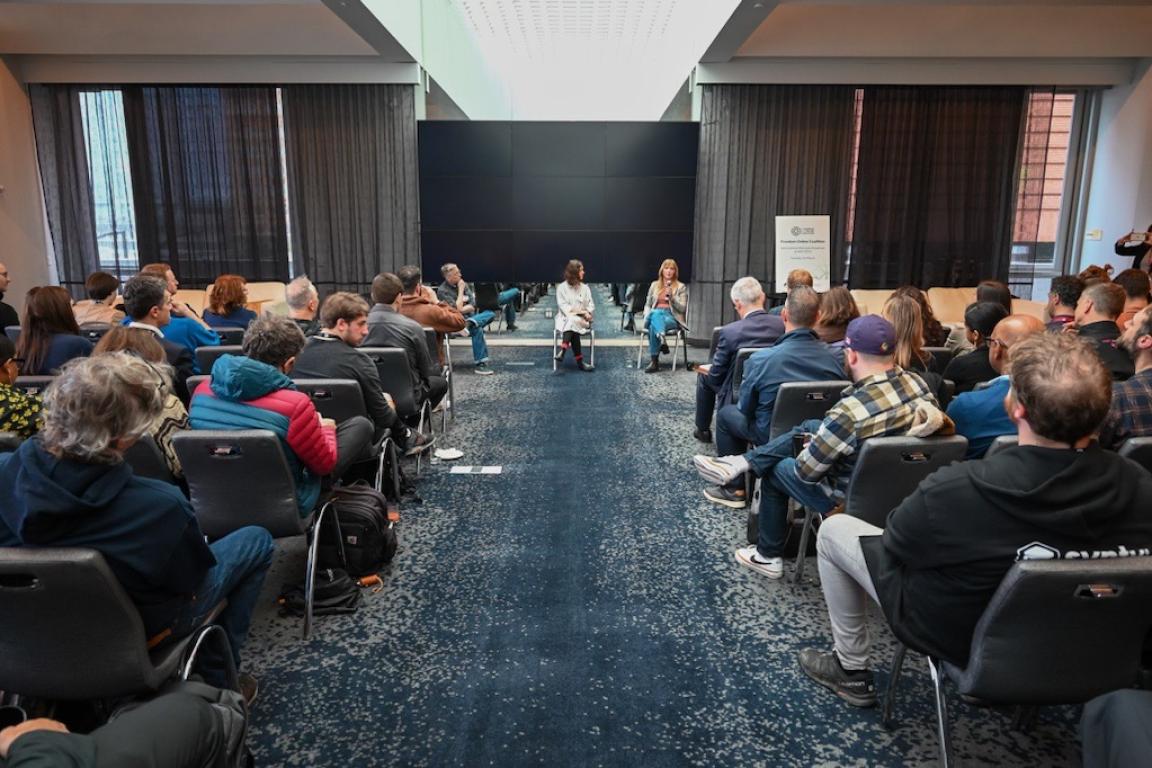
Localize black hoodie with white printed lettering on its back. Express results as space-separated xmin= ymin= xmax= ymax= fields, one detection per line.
xmin=861 ymin=442 xmax=1152 ymax=666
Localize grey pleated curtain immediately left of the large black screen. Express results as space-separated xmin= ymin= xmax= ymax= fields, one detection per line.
xmin=282 ymin=85 xmax=420 ymax=292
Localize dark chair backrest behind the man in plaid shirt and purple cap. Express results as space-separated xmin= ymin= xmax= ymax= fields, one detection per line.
xmin=844 ymin=435 xmax=968 ymax=529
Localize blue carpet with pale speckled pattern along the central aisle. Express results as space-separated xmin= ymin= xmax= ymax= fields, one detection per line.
xmin=244 ymin=292 xmax=1079 ymax=766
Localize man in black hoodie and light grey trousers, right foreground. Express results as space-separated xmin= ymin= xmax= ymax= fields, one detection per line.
xmin=799 ymin=334 xmax=1152 ymax=707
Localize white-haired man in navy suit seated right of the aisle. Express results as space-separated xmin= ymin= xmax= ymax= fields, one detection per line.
xmin=692 ymin=277 xmax=785 ymax=442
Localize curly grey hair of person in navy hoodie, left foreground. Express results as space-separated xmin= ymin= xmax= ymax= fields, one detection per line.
xmin=40 ymin=352 xmax=168 ymax=464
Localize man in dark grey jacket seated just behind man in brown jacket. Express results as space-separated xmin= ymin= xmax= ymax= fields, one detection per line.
xmin=364 ymin=272 xmax=448 ymax=408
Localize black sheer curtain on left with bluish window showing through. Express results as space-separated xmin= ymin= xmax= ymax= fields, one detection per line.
xmin=123 ymin=85 xmax=289 ymax=286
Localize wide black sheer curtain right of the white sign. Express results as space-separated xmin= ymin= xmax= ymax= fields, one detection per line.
xmin=849 ymin=85 xmax=1026 ymax=288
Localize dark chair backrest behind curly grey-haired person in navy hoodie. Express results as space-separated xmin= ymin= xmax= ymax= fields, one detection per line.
xmin=0 ymin=547 xmax=161 ymax=700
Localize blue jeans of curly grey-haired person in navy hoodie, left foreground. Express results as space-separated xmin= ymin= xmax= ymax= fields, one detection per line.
xmin=172 ymin=525 xmax=275 ymax=686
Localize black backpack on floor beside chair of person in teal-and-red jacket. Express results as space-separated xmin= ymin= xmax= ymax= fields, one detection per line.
xmin=317 ymin=481 xmax=400 ymax=577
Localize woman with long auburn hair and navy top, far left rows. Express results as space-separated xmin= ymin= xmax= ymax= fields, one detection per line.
xmin=16 ymin=286 xmax=92 ymax=377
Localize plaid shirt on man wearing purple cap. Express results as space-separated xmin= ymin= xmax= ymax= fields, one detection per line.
xmin=796 ymin=366 xmax=939 ymax=496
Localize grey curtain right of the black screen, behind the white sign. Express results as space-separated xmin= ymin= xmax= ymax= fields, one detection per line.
xmin=691 ymin=85 xmax=856 ymax=340
